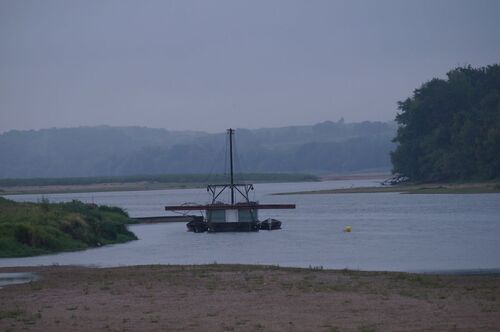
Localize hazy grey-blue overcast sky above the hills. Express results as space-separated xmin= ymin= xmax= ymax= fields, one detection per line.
xmin=0 ymin=0 xmax=500 ymax=132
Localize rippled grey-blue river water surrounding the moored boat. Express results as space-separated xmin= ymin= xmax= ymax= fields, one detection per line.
xmin=0 ymin=180 xmax=500 ymax=272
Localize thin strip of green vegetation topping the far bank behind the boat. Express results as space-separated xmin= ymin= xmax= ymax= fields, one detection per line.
xmin=0 ymin=173 xmax=319 ymax=187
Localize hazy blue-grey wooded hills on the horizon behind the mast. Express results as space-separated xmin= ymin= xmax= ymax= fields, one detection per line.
xmin=0 ymin=120 xmax=396 ymax=178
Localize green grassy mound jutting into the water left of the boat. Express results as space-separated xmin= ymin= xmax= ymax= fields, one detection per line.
xmin=0 ymin=197 xmax=137 ymax=257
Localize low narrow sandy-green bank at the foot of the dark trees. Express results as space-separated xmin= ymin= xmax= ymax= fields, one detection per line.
xmin=274 ymin=182 xmax=500 ymax=195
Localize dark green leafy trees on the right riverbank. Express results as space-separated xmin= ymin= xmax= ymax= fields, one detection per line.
xmin=391 ymin=64 xmax=500 ymax=181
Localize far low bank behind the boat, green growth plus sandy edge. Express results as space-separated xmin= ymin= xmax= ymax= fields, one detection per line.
xmin=0 ymin=173 xmax=319 ymax=195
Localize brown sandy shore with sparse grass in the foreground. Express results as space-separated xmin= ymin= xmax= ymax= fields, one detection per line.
xmin=0 ymin=264 xmax=500 ymax=331
